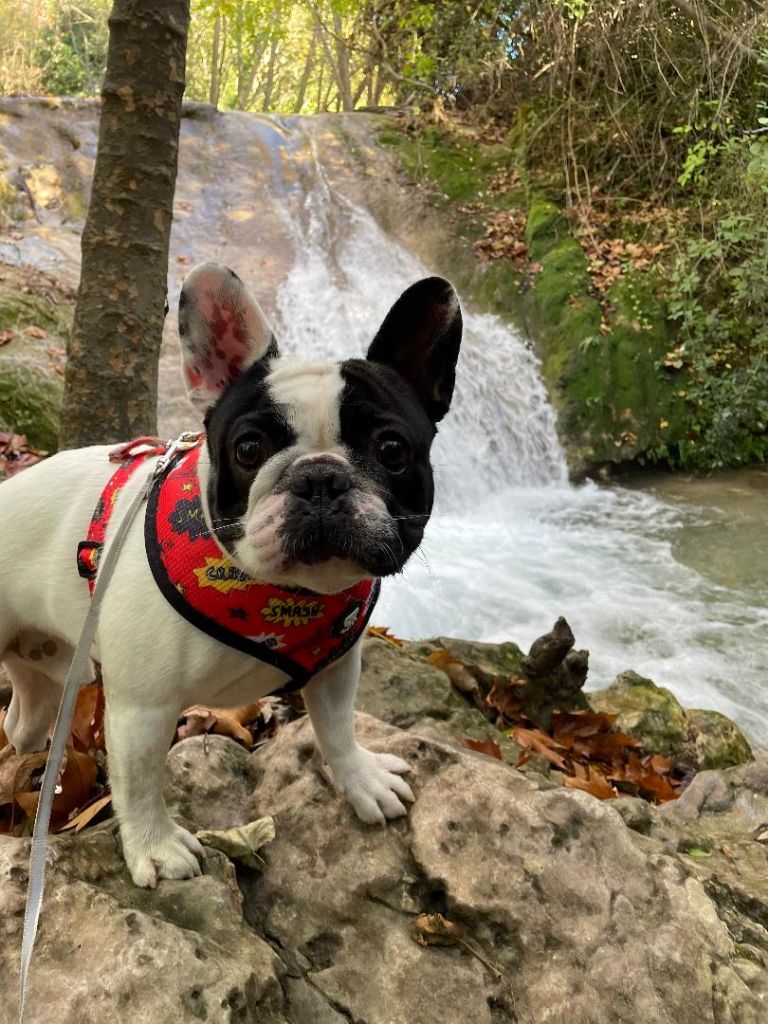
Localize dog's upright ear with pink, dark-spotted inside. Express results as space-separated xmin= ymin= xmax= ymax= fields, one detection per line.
xmin=178 ymin=263 xmax=278 ymax=406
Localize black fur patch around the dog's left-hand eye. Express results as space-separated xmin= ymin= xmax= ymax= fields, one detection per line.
xmin=205 ymin=358 xmax=296 ymax=552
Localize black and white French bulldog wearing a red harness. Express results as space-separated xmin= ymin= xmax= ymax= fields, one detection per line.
xmin=0 ymin=263 xmax=462 ymax=887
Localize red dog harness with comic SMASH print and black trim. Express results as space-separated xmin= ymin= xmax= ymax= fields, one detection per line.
xmin=78 ymin=438 xmax=380 ymax=690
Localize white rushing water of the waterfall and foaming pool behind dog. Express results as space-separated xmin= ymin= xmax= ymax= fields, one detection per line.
xmin=278 ymin=125 xmax=768 ymax=741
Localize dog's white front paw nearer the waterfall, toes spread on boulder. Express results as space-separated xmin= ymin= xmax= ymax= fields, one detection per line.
xmin=331 ymin=746 xmax=414 ymax=825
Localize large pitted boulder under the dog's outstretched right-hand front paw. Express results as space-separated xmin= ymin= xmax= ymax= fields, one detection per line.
xmin=242 ymin=716 xmax=768 ymax=1024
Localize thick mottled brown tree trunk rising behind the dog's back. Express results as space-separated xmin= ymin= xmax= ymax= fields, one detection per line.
xmin=60 ymin=0 xmax=189 ymax=447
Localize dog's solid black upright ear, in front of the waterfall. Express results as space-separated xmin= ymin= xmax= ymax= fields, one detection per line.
xmin=368 ymin=278 xmax=462 ymax=423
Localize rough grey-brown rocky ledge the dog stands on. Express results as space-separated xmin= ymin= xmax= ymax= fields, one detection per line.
xmin=0 ymin=626 xmax=768 ymax=1024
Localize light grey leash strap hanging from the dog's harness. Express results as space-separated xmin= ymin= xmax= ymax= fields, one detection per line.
xmin=18 ymin=434 xmax=187 ymax=1024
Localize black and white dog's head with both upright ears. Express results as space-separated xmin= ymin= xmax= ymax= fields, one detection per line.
xmin=179 ymin=263 xmax=462 ymax=593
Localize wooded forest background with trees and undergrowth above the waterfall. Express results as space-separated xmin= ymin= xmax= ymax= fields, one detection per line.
xmin=0 ymin=0 xmax=768 ymax=469
